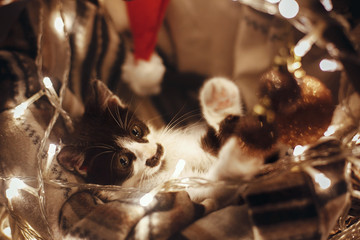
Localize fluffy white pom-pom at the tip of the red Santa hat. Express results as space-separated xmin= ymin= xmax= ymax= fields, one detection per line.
xmin=122 ymin=52 xmax=165 ymax=96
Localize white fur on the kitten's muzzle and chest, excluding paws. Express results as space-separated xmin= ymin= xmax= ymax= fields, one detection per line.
xmin=119 ymin=125 xmax=215 ymax=191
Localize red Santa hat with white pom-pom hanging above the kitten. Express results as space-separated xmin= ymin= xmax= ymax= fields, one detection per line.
xmin=123 ymin=0 xmax=170 ymax=95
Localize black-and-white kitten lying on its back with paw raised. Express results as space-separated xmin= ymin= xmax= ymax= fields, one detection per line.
xmin=57 ymin=78 xmax=262 ymax=199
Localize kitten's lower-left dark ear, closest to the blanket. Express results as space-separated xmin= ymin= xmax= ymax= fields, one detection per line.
xmin=57 ymin=146 xmax=87 ymax=178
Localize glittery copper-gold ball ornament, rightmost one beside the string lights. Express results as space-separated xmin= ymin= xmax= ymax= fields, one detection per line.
xmin=275 ymin=75 xmax=335 ymax=147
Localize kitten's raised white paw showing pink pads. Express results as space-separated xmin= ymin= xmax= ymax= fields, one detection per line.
xmin=200 ymin=77 xmax=242 ymax=130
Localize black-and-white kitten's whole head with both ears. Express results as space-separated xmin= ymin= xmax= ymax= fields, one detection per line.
xmin=58 ymin=81 xmax=164 ymax=187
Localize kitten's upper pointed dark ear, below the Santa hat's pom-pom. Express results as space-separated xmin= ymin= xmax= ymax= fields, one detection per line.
xmin=85 ymin=80 xmax=126 ymax=112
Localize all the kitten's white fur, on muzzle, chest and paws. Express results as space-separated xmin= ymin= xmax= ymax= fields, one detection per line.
xmin=115 ymin=78 xmax=262 ymax=201
